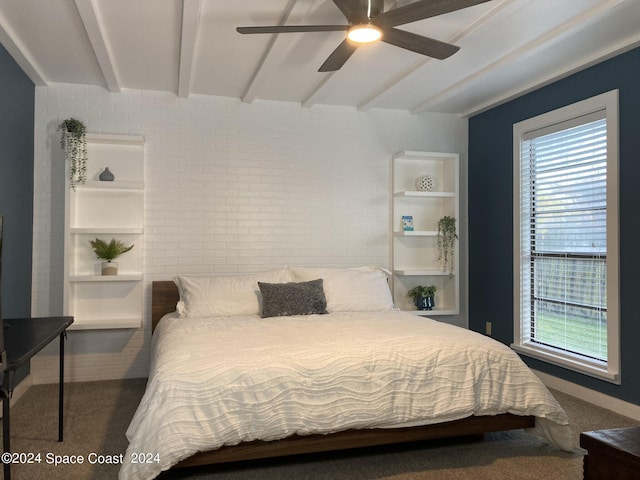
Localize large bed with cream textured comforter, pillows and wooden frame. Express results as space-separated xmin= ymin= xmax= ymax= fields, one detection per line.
xmin=119 ymin=267 xmax=573 ymax=480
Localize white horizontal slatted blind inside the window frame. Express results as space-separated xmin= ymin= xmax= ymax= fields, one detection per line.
xmin=520 ymin=111 xmax=607 ymax=362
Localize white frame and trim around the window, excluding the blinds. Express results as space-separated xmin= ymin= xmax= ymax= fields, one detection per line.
xmin=511 ymin=90 xmax=620 ymax=384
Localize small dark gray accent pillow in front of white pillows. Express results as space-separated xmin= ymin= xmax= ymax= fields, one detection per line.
xmin=258 ymin=278 xmax=328 ymax=318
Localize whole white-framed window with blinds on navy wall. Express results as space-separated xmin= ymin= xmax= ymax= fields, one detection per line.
xmin=512 ymin=91 xmax=620 ymax=383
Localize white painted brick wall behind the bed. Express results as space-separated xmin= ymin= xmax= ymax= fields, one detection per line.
xmin=32 ymin=85 xmax=467 ymax=383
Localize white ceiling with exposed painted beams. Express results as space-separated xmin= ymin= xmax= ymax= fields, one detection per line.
xmin=0 ymin=0 xmax=640 ymax=116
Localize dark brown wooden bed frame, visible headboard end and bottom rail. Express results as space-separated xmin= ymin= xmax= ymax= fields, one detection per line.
xmin=151 ymin=281 xmax=535 ymax=468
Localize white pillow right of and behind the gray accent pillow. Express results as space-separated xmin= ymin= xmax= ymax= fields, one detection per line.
xmin=290 ymin=267 xmax=394 ymax=313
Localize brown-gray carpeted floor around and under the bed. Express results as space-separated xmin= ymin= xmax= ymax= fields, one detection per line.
xmin=0 ymin=379 xmax=639 ymax=480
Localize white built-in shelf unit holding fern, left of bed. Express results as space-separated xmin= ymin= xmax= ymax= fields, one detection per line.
xmin=64 ymin=134 xmax=144 ymax=330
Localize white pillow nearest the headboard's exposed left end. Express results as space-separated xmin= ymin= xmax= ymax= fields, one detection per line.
xmin=174 ymin=268 xmax=291 ymax=318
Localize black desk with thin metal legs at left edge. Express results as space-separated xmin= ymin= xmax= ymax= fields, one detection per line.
xmin=2 ymin=317 xmax=73 ymax=480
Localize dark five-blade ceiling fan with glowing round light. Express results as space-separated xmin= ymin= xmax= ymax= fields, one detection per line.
xmin=236 ymin=0 xmax=489 ymax=72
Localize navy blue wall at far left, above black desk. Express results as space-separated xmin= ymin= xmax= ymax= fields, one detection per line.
xmin=0 ymin=45 xmax=35 ymax=380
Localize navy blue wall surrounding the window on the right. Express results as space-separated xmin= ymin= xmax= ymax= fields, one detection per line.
xmin=468 ymin=48 xmax=640 ymax=405
